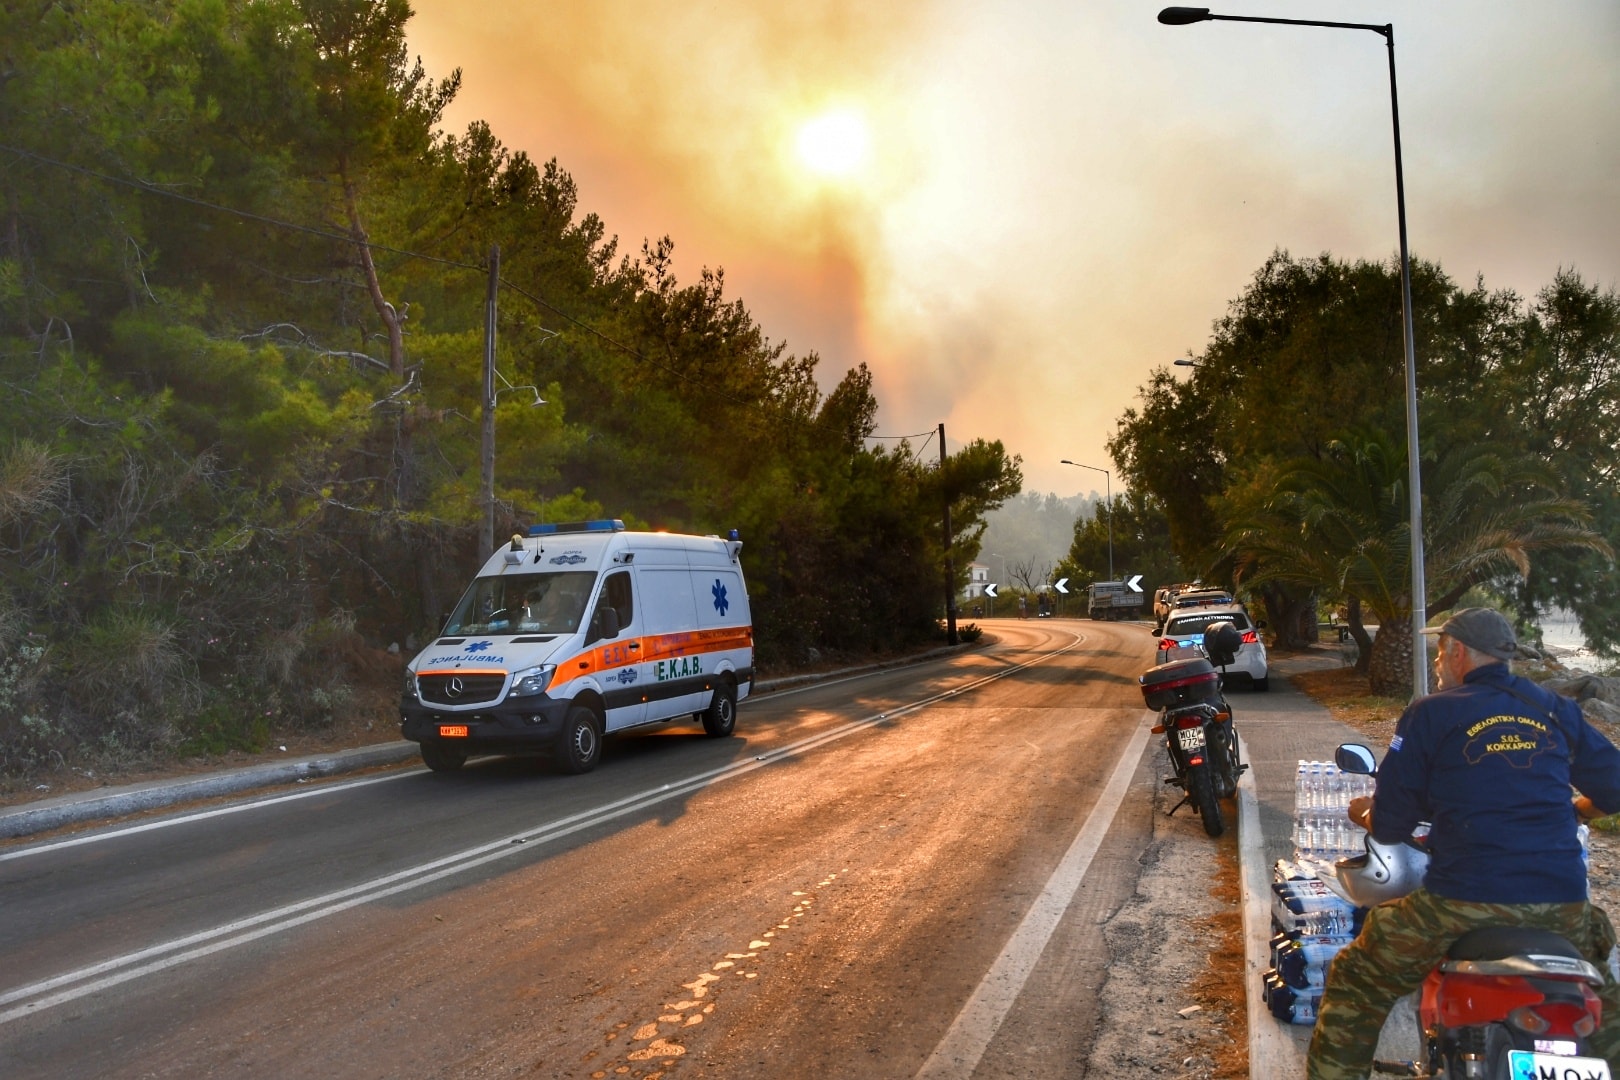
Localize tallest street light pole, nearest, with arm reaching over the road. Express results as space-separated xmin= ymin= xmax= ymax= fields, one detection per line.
xmin=1158 ymin=8 xmax=1429 ymax=698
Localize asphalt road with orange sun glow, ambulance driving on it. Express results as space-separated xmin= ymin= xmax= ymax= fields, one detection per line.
xmin=0 ymin=620 xmax=1197 ymax=1080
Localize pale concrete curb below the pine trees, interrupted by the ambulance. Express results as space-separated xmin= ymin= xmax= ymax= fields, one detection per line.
xmin=0 ymin=643 xmax=974 ymax=840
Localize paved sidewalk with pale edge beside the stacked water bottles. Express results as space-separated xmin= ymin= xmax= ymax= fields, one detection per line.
xmin=1228 ymin=646 xmax=1422 ymax=1080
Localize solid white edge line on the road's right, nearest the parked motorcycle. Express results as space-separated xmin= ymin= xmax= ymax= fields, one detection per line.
xmin=917 ymin=712 xmax=1158 ymax=1080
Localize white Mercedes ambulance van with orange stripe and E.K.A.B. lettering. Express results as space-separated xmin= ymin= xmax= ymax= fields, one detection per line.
xmin=400 ymin=520 xmax=753 ymax=772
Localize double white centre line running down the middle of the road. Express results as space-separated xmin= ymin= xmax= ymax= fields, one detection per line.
xmin=0 ymin=638 xmax=1081 ymax=1025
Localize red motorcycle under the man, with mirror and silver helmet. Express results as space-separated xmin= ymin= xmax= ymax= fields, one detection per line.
xmin=1328 ymin=743 xmax=1610 ymax=1080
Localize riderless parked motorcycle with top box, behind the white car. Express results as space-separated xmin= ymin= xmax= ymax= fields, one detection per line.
xmin=1137 ymin=622 xmax=1249 ymax=837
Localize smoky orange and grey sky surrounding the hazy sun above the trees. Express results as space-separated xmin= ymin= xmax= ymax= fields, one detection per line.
xmin=410 ymin=0 xmax=1620 ymax=495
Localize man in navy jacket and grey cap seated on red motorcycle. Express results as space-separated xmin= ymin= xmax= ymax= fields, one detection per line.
xmin=1306 ymin=607 xmax=1620 ymax=1080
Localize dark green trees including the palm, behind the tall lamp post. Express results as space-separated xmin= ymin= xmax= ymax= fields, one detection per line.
xmin=1110 ymin=253 xmax=1620 ymax=690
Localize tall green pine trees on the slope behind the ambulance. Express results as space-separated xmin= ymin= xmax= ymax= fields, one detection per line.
xmin=0 ymin=0 xmax=1021 ymax=771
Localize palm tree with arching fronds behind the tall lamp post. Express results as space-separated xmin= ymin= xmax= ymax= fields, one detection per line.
xmin=1223 ymin=431 xmax=1610 ymax=696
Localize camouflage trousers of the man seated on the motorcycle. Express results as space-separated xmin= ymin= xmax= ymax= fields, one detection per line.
xmin=1306 ymin=889 xmax=1620 ymax=1080
